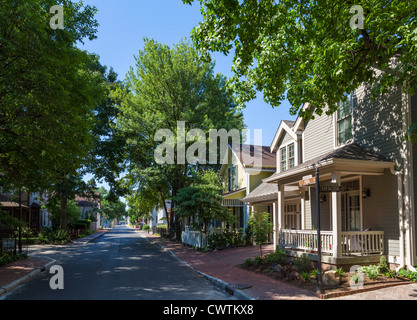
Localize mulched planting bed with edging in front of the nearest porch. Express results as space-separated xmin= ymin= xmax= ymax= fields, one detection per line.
xmin=238 ymin=264 xmax=411 ymax=299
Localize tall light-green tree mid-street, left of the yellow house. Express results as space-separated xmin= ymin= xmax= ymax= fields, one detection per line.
xmin=112 ymin=39 xmax=244 ymax=238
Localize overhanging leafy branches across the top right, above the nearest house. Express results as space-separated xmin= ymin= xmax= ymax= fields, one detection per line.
xmin=183 ymin=0 xmax=417 ymax=122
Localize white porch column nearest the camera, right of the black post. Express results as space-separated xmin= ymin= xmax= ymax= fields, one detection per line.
xmin=332 ymin=172 xmax=342 ymax=257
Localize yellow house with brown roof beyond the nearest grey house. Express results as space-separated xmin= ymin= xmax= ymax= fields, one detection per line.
xmin=219 ymin=143 xmax=276 ymax=232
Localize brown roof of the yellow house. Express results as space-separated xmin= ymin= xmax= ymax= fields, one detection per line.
xmin=229 ymin=143 xmax=277 ymax=169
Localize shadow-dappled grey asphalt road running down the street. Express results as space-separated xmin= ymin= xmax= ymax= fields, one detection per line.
xmin=4 ymin=226 xmax=232 ymax=300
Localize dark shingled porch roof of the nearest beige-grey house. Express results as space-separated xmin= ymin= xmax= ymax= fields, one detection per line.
xmin=263 ymin=143 xmax=393 ymax=182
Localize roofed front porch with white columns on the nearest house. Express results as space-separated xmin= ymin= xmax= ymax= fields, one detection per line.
xmin=264 ymin=147 xmax=399 ymax=265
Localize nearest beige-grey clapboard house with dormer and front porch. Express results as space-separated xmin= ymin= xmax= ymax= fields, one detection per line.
xmin=244 ymin=85 xmax=417 ymax=268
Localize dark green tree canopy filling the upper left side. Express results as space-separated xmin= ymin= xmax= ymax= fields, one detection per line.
xmin=0 ymin=0 xmax=103 ymax=190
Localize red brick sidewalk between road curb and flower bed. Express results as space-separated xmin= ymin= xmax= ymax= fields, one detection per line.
xmin=138 ymin=231 xmax=318 ymax=300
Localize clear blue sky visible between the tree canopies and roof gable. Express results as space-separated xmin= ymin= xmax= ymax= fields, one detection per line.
xmin=78 ymin=0 xmax=295 ymax=145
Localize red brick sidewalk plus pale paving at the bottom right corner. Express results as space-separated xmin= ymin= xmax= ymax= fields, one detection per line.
xmin=139 ymin=231 xmax=417 ymax=300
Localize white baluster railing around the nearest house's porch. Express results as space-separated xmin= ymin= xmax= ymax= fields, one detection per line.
xmin=279 ymin=229 xmax=384 ymax=255
